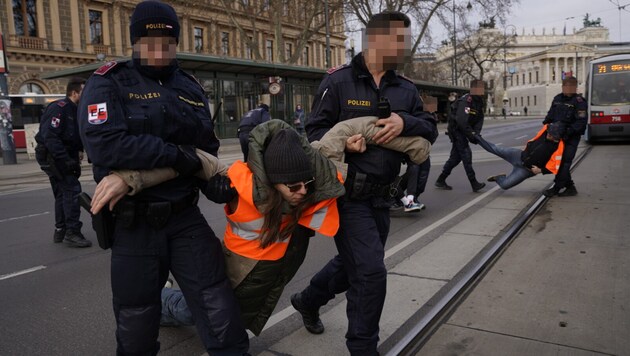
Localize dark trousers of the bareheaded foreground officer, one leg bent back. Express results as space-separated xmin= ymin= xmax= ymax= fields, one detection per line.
xmin=302 ymin=198 xmax=390 ymax=356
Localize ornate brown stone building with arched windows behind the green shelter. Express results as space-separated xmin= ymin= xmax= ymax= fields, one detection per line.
xmin=0 ymin=0 xmax=345 ymax=94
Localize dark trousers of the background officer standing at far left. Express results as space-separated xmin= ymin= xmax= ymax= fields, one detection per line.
xmin=48 ymin=175 xmax=83 ymax=232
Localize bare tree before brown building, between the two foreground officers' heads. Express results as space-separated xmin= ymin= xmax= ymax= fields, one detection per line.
xmin=221 ymin=0 xmax=343 ymax=64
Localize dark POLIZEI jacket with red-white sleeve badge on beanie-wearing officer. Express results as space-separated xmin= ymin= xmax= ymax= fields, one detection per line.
xmin=79 ymin=61 xmax=219 ymax=201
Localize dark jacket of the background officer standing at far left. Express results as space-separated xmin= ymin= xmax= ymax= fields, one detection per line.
xmin=35 ymin=97 xmax=83 ymax=163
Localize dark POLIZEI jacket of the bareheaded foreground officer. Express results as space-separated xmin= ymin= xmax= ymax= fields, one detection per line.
xmin=305 ymin=53 xmax=438 ymax=184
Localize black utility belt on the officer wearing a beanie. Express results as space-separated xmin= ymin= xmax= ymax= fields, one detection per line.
xmin=114 ymin=188 xmax=199 ymax=230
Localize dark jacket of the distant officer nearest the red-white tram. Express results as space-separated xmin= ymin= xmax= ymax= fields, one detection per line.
xmin=543 ymin=93 xmax=588 ymax=138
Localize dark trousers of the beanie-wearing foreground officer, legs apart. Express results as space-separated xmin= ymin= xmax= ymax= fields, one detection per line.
xmin=111 ymin=205 xmax=249 ymax=355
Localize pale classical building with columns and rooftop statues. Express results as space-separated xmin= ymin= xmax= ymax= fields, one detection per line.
xmin=436 ymin=25 xmax=630 ymax=115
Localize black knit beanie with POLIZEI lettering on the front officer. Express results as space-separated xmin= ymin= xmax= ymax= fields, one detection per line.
xmin=129 ymin=1 xmax=179 ymax=43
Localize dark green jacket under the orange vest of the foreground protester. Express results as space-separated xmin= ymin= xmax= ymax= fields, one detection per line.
xmin=223 ymin=120 xmax=345 ymax=335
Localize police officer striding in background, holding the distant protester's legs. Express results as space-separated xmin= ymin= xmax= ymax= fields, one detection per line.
xmin=435 ymin=80 xmax=486 ymax=192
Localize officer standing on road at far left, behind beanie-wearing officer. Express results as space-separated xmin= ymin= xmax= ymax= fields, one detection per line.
xmin=35 ymin=78 xmax=92 ymax=247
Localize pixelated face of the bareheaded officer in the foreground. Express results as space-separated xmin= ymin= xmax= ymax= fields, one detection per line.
xmin=365 ymin=21 xmax=411 ymax=70
